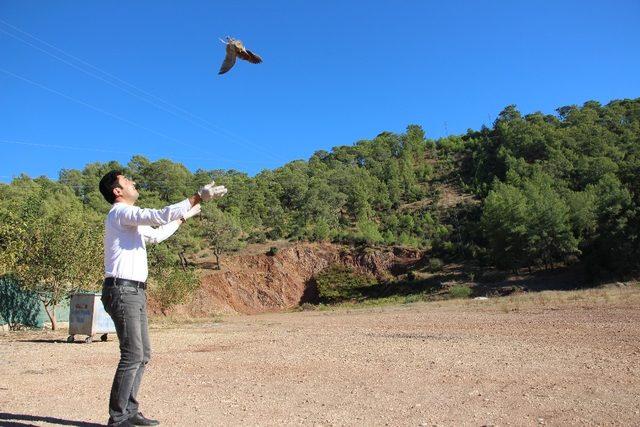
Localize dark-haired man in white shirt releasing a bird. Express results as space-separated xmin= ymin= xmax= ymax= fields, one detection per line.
xmin=95 ymin=170 xmax=227 ymax=427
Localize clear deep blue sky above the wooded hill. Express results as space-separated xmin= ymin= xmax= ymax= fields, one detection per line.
xmin=0 ymin=0 xmax=640 ymax=182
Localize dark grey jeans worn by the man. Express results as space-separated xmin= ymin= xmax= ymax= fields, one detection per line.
xmin=102 ymin=285 xmax=151 ymax=425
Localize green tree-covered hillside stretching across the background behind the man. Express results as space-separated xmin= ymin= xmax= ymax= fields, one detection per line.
xmin=0 ymin=99 xmax=640 ymax=318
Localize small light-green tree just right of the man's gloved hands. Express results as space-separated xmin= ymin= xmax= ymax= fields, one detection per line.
xmin=203 ymin=208 xmax=242 ymax=270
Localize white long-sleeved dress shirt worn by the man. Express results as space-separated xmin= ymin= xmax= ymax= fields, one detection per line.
xmin=104 ymin=199 xmax=191 ymax=282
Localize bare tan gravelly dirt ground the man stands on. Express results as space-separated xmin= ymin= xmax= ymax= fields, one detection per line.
xmin=0 ymin=286 xmax=640 ymax=426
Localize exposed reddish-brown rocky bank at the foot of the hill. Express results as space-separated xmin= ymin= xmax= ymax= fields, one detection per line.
xmin=151 ymin=243 xmax=421 ymax=317
